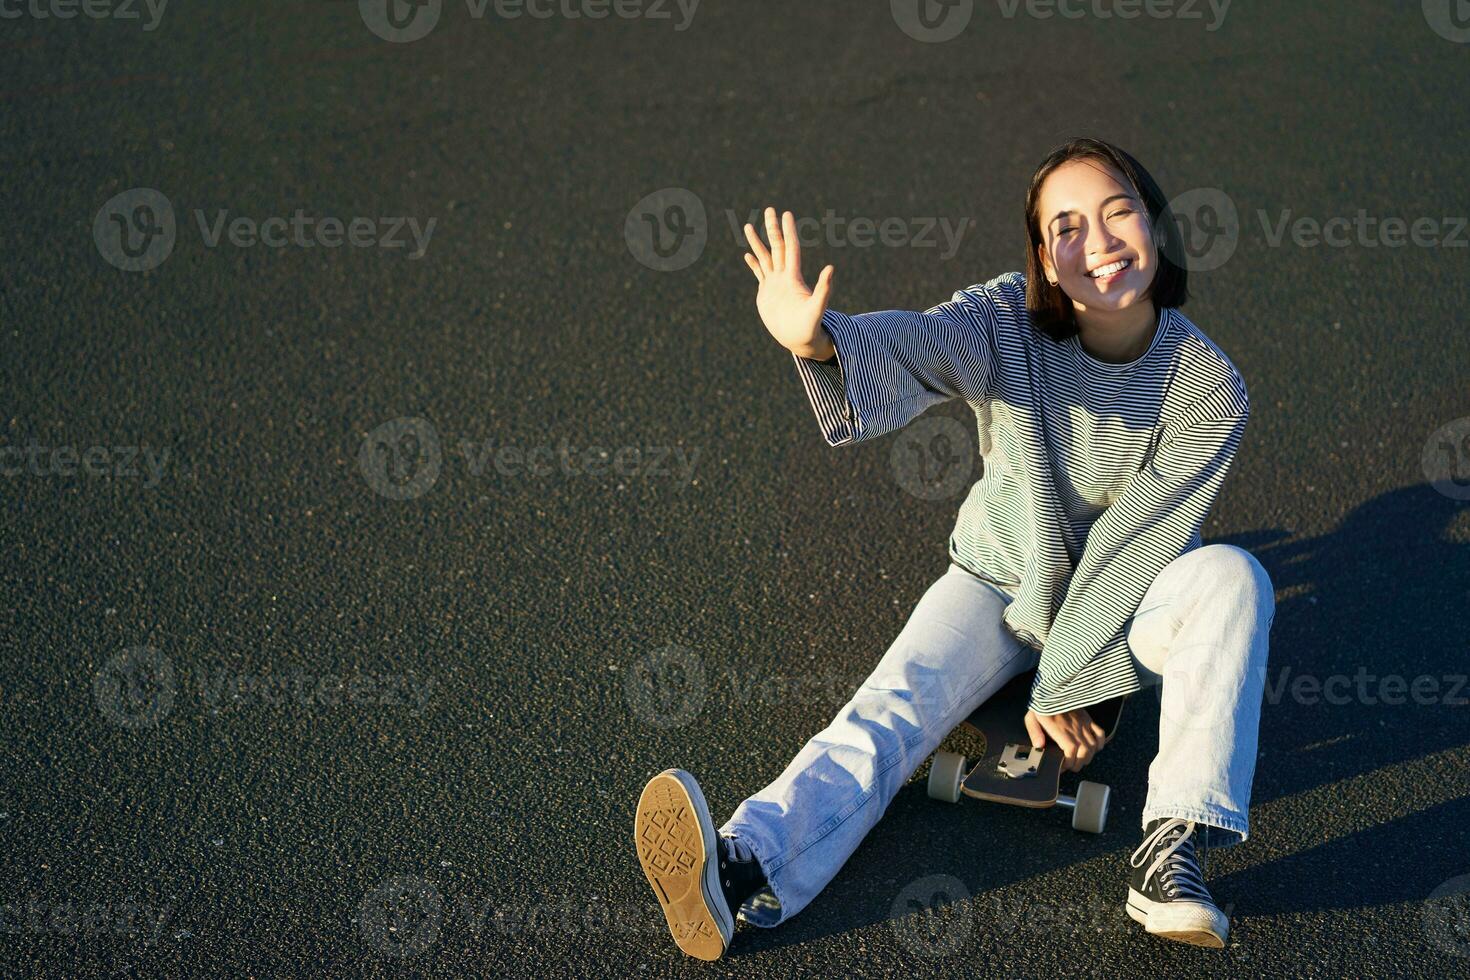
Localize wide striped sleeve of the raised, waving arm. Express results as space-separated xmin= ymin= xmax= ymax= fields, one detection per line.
xmin=792 ymin=287 xmax=995 ymax=445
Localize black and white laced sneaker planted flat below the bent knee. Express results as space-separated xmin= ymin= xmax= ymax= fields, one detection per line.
xmin=1127 ymin=817 xmax=1230 ymax=949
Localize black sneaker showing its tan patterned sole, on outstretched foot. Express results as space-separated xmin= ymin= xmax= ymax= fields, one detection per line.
xmin=634 ymin=768 xmax=766 ymax=959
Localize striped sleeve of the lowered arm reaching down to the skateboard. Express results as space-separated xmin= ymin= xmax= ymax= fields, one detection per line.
xmin=1030 ymin=378 xmax=1250 ymax=714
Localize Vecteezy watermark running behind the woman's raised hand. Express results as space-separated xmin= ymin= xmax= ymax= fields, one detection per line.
xmin=623 ymin=187 xmax=976 ymax=272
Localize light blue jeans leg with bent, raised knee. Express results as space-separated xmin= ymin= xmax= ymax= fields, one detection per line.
xmin=1127 ymin=544 xmax=1276 ymax=846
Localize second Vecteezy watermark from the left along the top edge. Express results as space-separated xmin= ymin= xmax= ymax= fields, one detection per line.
xmin=357 ymin=0 xmax=700 ymax=44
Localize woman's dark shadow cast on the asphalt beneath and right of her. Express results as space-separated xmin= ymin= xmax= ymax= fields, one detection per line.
xmin=728 ymin=483 xmax=1470 ymax=956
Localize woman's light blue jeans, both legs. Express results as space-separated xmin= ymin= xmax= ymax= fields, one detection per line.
xmin=720 ymin=544 xmax=1276 ymax=927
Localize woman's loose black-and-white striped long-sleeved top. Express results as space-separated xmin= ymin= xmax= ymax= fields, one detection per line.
xmin=792 ymin=272 xmax=1250 ymax=714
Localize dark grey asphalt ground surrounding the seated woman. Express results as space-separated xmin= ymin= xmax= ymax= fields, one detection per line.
xmin=0 ymin=0 xmax=1470 ymax=977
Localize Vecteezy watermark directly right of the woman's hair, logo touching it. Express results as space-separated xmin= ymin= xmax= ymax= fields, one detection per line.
xmin=1155 ymin=187 xmax=1470 ymax=272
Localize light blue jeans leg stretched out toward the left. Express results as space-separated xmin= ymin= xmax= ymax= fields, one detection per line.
xmin=720 ymin=564 xmax=1036 ymax=927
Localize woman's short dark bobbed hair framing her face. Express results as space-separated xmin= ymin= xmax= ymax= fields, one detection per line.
xmin=1026 ymin=137 xmax=1189 ymax=342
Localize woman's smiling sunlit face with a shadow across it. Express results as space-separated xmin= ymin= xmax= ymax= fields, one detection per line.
xmin=1036 ymin=159 xmax=1158 ymax=316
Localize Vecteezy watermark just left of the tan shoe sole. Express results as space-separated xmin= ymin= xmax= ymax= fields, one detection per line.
xmin=357 ymin=874 xmax=667 ymax=959
